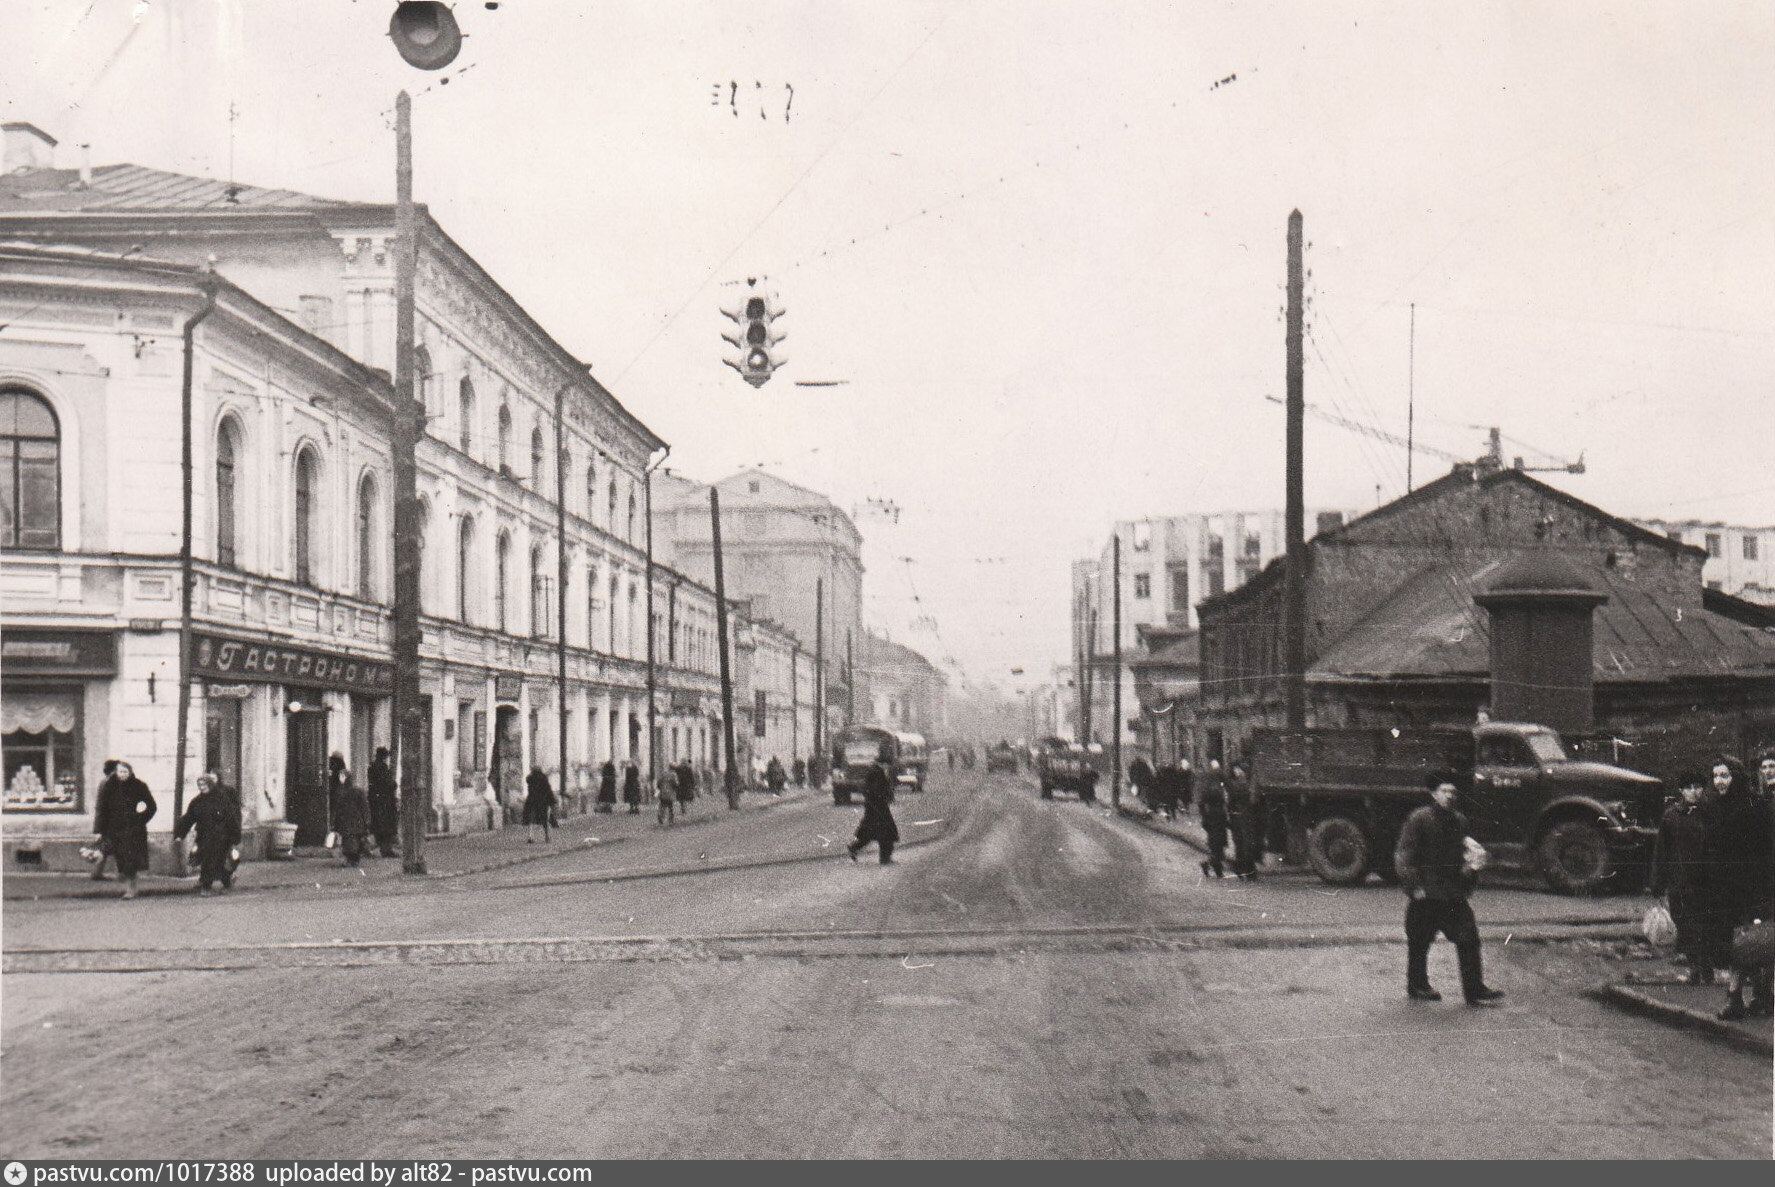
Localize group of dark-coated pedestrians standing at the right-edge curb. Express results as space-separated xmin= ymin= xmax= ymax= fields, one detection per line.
xmin=1649 ymin=749 xmax=1775 ymax=1020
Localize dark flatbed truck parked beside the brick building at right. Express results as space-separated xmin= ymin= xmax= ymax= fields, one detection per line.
xmin=1248 ymin=722 xmax=1663 ymax=894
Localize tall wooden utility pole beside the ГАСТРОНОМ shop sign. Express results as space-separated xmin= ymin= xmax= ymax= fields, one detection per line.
xmin=391 ymin=90 xmax=430 ymax=875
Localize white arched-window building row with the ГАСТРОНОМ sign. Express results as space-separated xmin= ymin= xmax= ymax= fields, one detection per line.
xmin=0 ymin=126 xmax=802 ymax=865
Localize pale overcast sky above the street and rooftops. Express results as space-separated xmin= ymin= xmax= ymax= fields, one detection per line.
xmin=0 ymin=0 xmax=1775 ymax=685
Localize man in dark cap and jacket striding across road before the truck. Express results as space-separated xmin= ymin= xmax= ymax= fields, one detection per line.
xmin=1393 ymin=772 xmax=1503 ymax=1006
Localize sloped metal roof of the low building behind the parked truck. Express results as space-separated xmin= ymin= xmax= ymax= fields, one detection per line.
xmin=1308 ymin=561 xmax=1775 ymax=683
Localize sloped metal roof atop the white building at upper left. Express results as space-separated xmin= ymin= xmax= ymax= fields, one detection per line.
xmin=0 ymin=165 xmax=350 ymax=213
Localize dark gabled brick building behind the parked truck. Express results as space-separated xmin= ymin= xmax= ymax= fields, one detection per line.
xmin=1193 ymin=467 xmax=1775 ymax=777
